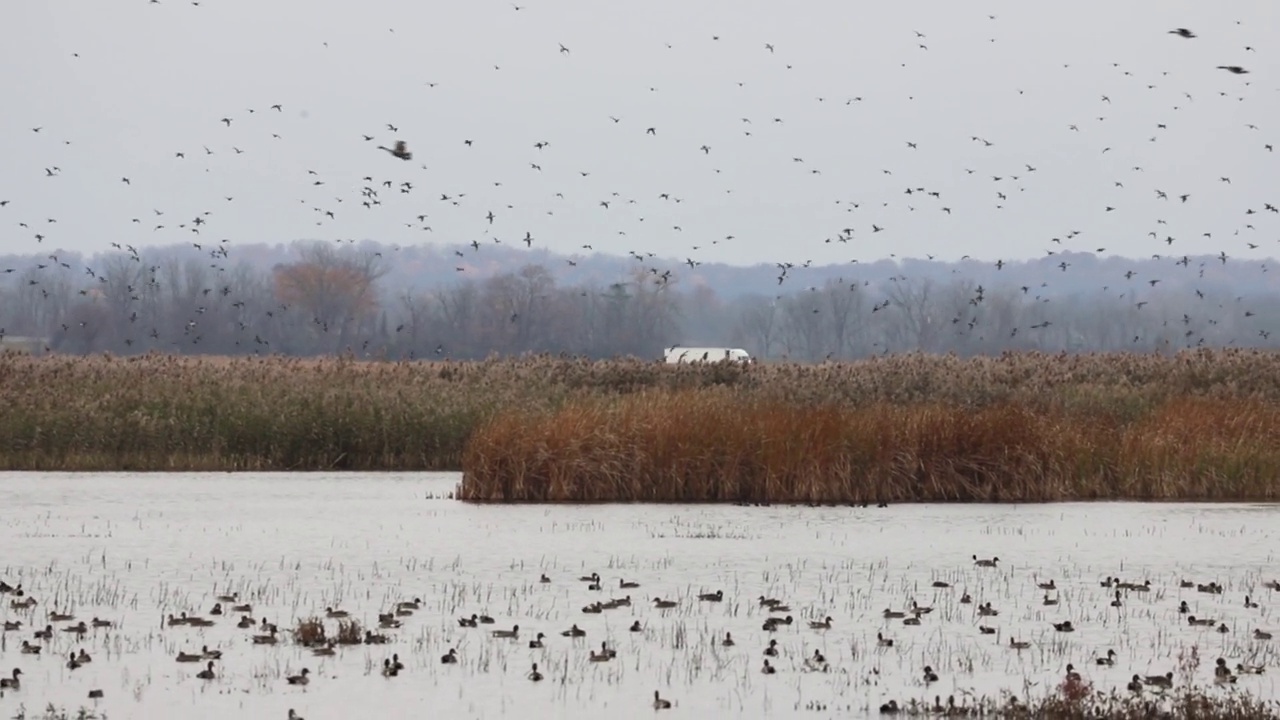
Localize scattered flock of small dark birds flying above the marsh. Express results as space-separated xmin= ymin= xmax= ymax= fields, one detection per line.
xmin=0 ymin=6 xmax=1280 ymax=352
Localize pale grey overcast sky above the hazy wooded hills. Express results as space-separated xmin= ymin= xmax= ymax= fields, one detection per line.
xmin=0 ymin=0 xmax=1280 ymax=264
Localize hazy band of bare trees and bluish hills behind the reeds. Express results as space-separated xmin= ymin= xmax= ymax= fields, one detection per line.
xmin=0 ymin=242 xmax=1280 ymax=361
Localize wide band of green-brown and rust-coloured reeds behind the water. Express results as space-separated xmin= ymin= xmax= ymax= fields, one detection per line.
xmin=0 ymin=350 xmax=1280 ymax=503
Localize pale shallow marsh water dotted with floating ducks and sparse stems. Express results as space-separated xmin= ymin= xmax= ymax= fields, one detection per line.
xmin=0 ymin=473 xmax=1280 ymax=720
